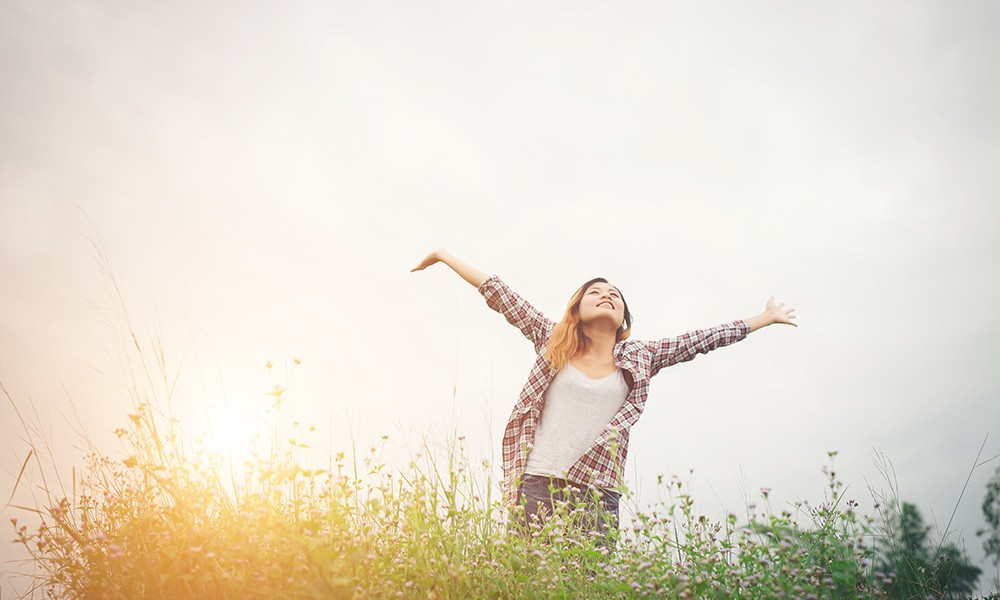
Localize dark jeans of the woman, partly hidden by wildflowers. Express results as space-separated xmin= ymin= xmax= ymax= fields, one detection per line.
xmin=512 ymin=475 xmax=621 ymax=546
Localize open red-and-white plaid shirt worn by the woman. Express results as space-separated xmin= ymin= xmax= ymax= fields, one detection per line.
xmin=479 ymin=275 xmax=750 ymax=504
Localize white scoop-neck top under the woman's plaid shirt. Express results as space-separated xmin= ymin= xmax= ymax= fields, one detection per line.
xmin=524 ymin=362 xmax=628 ymax=477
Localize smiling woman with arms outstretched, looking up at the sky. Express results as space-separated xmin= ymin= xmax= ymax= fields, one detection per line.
xmin=411 ymin=248 xmax=797 ymax=532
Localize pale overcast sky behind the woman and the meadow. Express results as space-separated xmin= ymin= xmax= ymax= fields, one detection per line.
xmin=0 ymin=0 xmax=1000 ymax=584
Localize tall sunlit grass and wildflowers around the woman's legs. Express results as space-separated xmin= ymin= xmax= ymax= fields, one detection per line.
xmin=7 ymin=364 xmax=980 ymax=599
